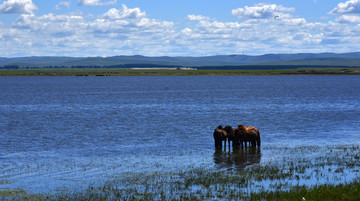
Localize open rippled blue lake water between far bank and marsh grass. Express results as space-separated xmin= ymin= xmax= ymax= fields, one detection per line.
xmin=0 ymin=76 xmax=360 ymax=193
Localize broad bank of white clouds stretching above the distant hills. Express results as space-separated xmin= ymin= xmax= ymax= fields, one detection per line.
xmin=0 ymin=4 xmax=360 ymax=56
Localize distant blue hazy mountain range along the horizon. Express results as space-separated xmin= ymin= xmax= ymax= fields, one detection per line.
xmin=0 ymin=52 xmax=360 ymax=69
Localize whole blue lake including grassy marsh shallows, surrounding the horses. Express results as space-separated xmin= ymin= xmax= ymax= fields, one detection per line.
xmin=0 ymin=75 xmax=360 ymax=200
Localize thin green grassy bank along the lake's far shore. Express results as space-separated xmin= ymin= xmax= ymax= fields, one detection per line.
xmin=0 ymin=68 xmax=360 ymax=76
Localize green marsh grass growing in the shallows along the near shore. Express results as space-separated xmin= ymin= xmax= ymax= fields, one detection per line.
xmin=0 ymin=145 xmax=360 ymax=200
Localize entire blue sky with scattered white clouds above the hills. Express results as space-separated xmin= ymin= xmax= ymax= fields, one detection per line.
xmin=0 ymin=0 xmax=360 ymax=57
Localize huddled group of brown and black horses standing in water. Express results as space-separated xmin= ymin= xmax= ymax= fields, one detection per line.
xmin=214 ymin=125 xmax=260 ymax=149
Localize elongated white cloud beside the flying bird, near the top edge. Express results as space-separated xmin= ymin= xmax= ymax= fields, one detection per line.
xmin=231 ymin=4 xmax=294 ymax=19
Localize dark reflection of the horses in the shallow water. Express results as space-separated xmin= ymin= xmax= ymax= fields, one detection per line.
xmin=214 ymin=147 xmax=261 ymax=169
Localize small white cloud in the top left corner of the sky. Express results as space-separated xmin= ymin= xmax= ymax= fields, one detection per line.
xmin=0 ymin=0 xmax=38 ymax=13
